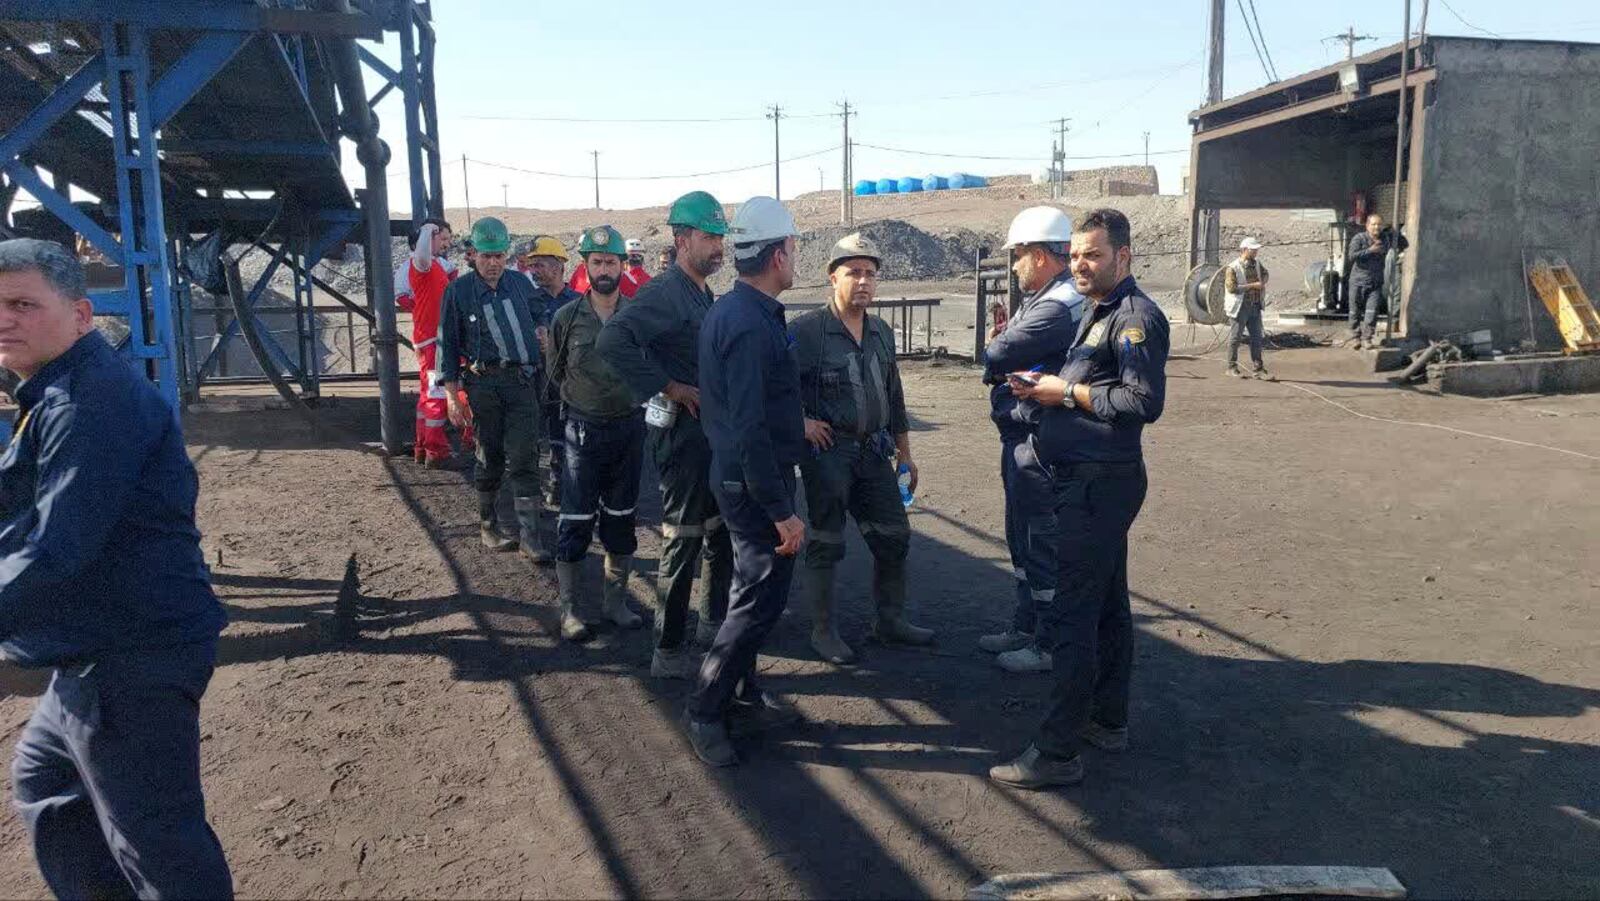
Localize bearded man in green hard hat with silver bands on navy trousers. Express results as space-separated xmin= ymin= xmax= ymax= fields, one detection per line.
xmin=550 ymin=226 xmax=645 ymax=642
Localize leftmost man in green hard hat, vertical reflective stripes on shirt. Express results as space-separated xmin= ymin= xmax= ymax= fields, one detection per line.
xmin=438 ymin=216 xmax=550 ymax=565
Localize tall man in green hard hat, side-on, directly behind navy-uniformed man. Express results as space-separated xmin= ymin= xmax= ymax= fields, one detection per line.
xmin=595 ymin=190 xmax=733 ymax=679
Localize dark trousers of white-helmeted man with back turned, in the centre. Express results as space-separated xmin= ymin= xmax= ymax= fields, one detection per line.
xmin=690 ymin=466 xmax=795 ymax=723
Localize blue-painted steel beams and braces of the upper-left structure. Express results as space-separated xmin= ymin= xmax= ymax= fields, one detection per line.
xmin=0 ymin=0 xmax=443 ymax=405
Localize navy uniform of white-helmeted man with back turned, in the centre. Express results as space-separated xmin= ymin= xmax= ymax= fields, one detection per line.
xmin=690 ymin=282 xmax=810 ymax=723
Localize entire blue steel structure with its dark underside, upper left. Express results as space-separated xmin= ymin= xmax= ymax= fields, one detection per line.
xmin=0 ymin=0 xmax=443 ymax=450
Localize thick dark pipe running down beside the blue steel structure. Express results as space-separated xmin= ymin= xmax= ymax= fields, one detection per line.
xmin=323 ymin=0 xmax=406 ymax=456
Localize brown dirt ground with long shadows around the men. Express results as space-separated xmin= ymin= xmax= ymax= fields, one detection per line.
xmin=0 ymin=328 xmax=1600 ymax=898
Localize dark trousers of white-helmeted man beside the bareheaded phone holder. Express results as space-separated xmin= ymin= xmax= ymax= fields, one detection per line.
xmin=1000 ymin=434 xmax=1056 ymax=634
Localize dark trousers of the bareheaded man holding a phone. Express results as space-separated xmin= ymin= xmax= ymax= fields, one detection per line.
xmin=1034 ymin=461 xmax=1147 ymax=757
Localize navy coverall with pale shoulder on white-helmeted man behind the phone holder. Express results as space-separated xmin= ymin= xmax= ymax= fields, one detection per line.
xmin=984 ymin=272 xmax=1083 ymax=634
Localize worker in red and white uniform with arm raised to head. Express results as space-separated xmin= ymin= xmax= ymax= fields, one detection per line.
xmin=395 ymin=219 xmax=472 ymax=469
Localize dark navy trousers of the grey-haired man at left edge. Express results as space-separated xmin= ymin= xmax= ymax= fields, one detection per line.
xmin=11 ymin=643 xmax=234 ymax=898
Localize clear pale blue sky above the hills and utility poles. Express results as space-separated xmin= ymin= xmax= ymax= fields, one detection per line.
xmin=352 ymin=0 xmax=1600 ymax=211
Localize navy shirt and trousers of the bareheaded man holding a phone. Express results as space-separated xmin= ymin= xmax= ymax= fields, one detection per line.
xmin=1034 ymin=275 xmax=1170 ymax=759
